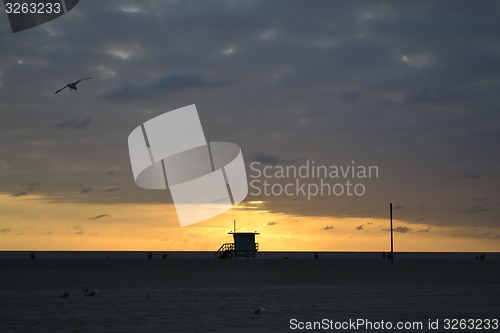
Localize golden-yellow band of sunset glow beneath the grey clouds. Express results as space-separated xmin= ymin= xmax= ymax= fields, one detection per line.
xmin=0 ymin=195 xmax=500 ymax=252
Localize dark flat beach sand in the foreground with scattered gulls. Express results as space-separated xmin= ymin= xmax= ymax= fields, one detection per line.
xmin=0 ymin=259 xmax=500 ymax=332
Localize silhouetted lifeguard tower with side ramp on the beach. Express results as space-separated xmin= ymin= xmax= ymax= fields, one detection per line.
xmin=214 ymin=223 xmax=259 ymax=259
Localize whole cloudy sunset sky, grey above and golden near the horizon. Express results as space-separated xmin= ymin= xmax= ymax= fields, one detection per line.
xmin=0 ymin=0 xmax=500 ymax=252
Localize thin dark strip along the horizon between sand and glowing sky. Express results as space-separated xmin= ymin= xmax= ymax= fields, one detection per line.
xmin=0 ymin=250 xmax=500 ymax=260
